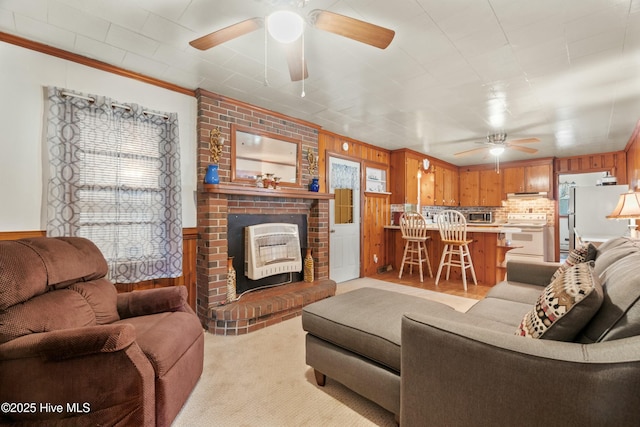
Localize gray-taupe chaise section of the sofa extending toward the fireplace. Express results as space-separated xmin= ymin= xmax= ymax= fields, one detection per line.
xmin=302 ymin=288 xmax=453 ymax=373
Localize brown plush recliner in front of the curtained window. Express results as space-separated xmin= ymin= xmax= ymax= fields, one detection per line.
xmin=0 ymin=237 xmax=204 ymax=426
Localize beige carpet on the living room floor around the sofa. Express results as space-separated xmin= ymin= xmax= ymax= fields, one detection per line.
xmin=173 ymin=278 xmax=477 ymax=427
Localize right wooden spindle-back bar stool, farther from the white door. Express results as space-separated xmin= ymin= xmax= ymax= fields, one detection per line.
xmin=436 ymin=210 xmax=478 ymax=291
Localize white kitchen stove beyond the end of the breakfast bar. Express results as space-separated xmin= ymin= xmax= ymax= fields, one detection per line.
xmin=505 ymin=214 xmax=550 ymax=262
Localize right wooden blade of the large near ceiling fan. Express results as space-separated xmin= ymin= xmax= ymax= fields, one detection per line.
xmin=309 ymin=9 xmax=396 ymax=49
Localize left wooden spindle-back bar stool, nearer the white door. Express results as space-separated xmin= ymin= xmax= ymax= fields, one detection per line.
xmin=398 ymin=212 xmax=433 ymax=282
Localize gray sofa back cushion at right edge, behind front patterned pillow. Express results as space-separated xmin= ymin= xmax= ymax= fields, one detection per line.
xmin=576 ymin=254 xmax=640 ymax=343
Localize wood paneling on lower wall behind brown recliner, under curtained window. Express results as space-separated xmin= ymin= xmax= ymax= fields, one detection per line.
xmin=0 ymin=228 xmax=198 ymax=310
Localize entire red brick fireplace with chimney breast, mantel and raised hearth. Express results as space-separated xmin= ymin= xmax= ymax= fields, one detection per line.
xmin=196 ymin=91 xmax=335 ymax=335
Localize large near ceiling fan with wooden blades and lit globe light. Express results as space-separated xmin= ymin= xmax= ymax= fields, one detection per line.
xmin=189 ymin=2 xmax=395 ymax=81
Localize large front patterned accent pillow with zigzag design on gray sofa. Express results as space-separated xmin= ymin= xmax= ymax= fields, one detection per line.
xmin=516 ymin=261 xmax=604 ymax=341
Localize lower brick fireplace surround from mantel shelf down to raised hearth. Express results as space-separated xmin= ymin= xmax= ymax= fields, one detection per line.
xmin=196 ymin=184 xmax=335 ymax=335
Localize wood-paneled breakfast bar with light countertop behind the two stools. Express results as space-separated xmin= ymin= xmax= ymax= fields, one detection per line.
xmin=384 ymin=224 xmax=520 ymax=286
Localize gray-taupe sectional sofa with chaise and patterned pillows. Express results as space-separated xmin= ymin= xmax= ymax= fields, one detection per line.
xmin=302 ymin=238 xmax=640 ymax=427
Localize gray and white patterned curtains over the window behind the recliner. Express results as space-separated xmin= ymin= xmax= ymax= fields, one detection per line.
xmin=46 ymin=87 xmax=182 ymax=283
